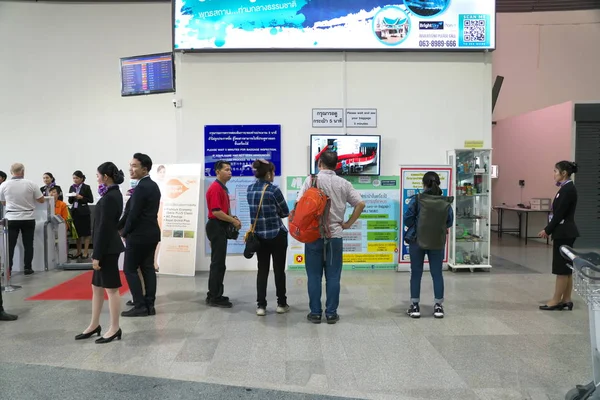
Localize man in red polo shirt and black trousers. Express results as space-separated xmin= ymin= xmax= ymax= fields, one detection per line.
xmin=206 ymin=161 xmax=242 ymax=308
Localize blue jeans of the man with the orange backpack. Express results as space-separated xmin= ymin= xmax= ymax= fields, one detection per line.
xmin=305 ymin=238 xmax=344 ymax=315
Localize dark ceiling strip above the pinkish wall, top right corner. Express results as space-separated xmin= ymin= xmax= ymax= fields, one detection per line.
xmin=13 ymin=0 xmax=600 ymax=13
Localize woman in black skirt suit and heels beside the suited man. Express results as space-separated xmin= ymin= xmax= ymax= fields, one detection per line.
xmin=75 ymin=162 xmax=125 ymax=343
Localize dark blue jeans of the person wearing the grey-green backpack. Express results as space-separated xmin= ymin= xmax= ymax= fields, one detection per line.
xmin=408 ymin=242 xmax=444 ymax=304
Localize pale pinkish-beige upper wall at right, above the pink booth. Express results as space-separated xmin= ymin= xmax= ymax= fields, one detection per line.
xmin=492 ymin=10 xmax=600 ymax=120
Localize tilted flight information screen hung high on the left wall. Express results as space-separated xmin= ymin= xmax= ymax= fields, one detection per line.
xmin=121 ymin=52 xmax=175 ymax=96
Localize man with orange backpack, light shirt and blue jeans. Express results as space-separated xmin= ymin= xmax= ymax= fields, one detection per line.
xmin=290 ymin=151 xmax=365 ymax=324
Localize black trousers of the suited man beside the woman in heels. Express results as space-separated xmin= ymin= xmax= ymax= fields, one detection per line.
xmin=123 ymin=243 xmax=158 ymax=308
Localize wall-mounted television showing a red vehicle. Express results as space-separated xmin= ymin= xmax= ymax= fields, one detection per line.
xmin=310 ymin=135 xmax=381 ymax=176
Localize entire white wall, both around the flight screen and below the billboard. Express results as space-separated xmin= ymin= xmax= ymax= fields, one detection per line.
xmin=0 ymin=2 xmax=492 ymax=269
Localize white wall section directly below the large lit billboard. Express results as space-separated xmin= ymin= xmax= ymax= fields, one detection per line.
xmin=177 ymin=53 xmax=492 ymax=269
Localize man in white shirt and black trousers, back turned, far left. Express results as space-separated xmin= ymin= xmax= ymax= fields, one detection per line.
xmin=0 ymin=163 xmax=44 ymax=275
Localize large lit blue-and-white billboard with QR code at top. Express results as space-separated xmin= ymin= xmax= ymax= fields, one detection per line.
xmin=173 ymin=0 xmax=496 ymax=51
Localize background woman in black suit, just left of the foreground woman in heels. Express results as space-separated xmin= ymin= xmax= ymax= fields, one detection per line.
xmin=69 ymin=171 xmax=94 ymax=259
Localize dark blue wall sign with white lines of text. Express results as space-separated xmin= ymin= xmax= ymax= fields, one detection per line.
xmin=204 ymin=125 xmax=281 ymax=176
